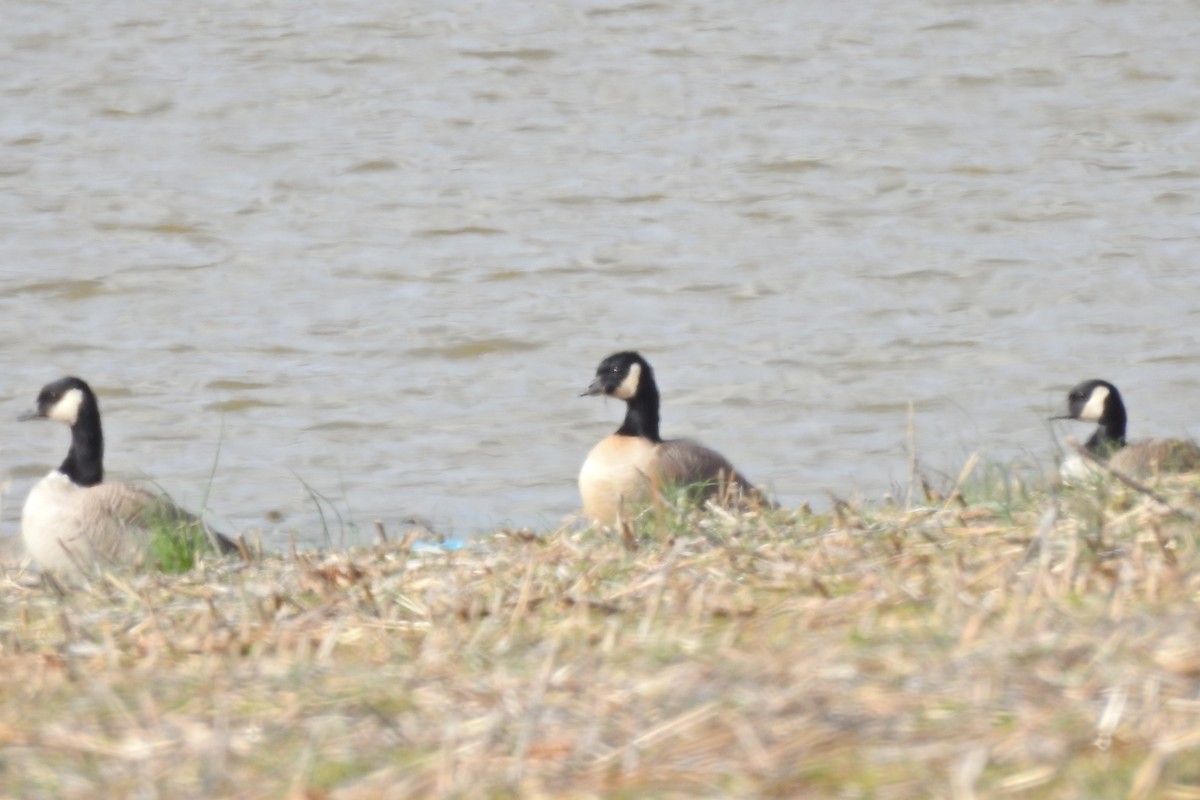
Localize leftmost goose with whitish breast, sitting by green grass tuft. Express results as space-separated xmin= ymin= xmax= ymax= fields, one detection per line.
xmin=17 ymin=377 xmax=238 ymax=573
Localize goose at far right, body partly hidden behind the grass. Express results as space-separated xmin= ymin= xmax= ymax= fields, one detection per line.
xmin=1054 ymin=379 xmax=1200 ymax=480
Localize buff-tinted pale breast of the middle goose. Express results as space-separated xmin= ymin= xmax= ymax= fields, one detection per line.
xmin=580 ymin=434 xmax=655 ymax=524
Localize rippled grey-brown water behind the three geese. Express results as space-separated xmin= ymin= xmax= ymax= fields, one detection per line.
xmin=0 ymin=0 xmax=1200 ymax=542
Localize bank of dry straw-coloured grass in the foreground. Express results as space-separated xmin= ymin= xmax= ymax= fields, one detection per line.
xmin=0 ymin=470 xmax=1200 ymax=799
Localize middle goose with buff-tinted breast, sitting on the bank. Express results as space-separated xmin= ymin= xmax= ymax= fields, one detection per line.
xmin=580 ymin=350 xmax=767 ymax=525
